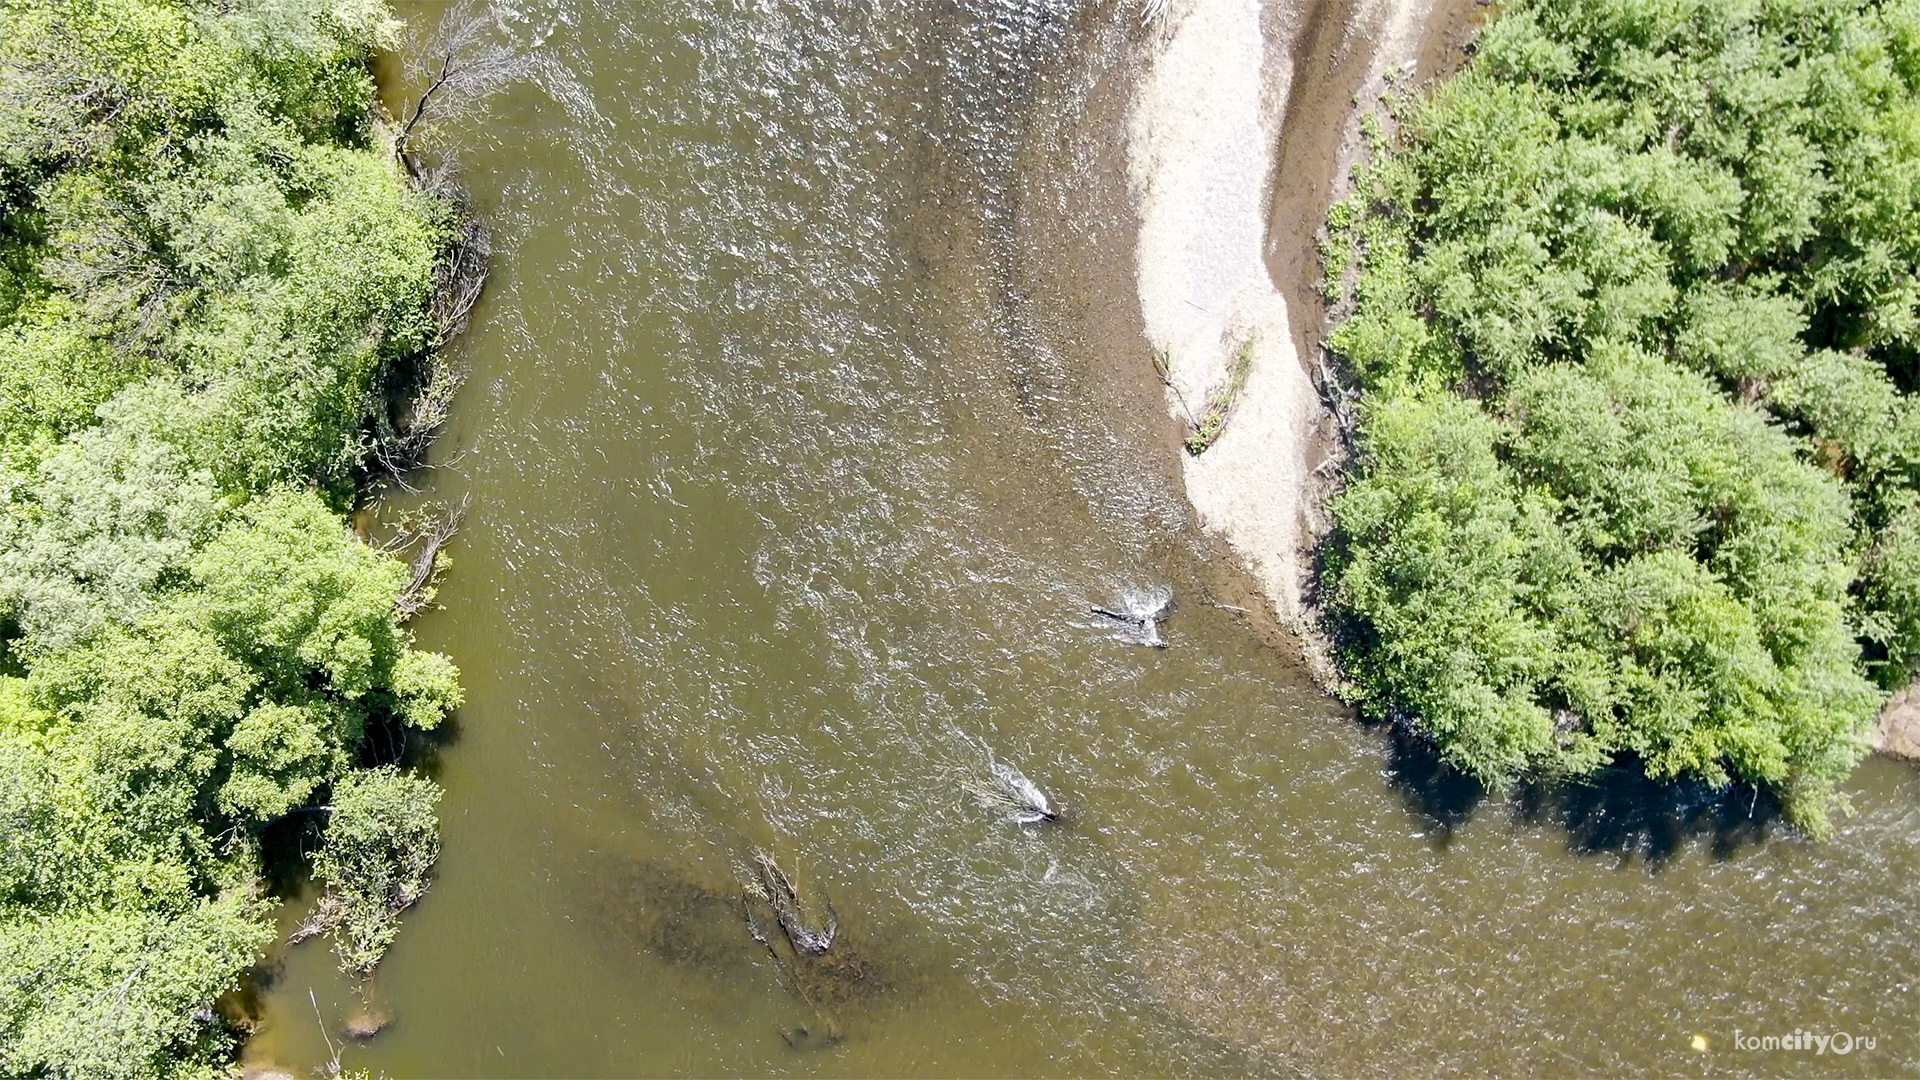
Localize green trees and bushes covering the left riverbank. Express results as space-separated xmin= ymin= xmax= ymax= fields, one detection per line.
xmin=0 ymin=0 xmax=467 ymax=1076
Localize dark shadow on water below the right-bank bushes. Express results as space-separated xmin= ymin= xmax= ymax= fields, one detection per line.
xmin=1386 ymin=723 xmax=1784 ymax=869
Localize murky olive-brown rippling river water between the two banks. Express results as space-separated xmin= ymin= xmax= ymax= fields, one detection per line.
xmin=250 ymin=0 xmax=1920 ymax=1076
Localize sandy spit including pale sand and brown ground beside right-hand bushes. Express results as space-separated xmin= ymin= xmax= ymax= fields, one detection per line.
xmin=1127 ymin=0 xmax=1475 ymax=630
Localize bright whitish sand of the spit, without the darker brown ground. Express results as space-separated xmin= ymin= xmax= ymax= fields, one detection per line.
xmin=1127 ymin=0 xmax=1430 ymax=626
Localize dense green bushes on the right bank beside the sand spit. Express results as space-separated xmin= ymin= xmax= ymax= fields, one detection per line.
xmin=1321 ymin=0 xmax=1920 ymax=834
